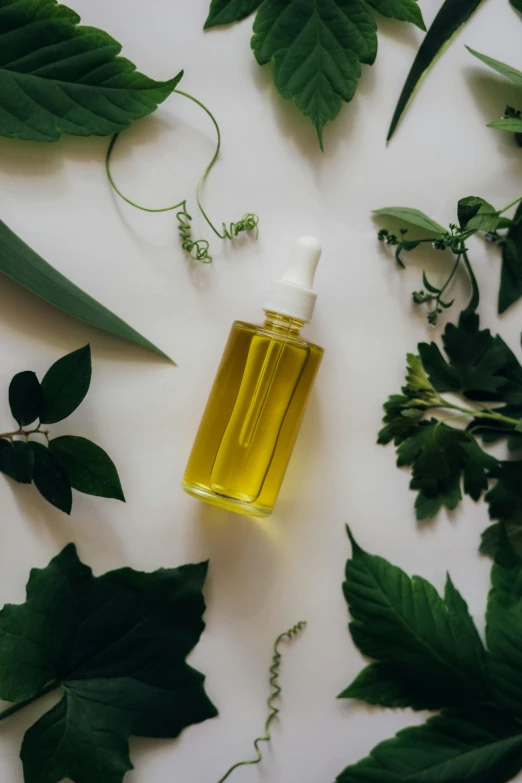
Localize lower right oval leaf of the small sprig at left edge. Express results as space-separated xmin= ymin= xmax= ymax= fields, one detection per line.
xmin=49 ymin=435 xmax=125 ymax=501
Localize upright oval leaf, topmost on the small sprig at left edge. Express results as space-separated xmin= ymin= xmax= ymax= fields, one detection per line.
xmin=41 ymin=345 xmax=92 ymax=424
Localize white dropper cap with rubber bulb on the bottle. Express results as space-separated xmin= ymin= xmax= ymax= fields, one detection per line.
xmin=263 ymin=237 xmax=322 ymax=323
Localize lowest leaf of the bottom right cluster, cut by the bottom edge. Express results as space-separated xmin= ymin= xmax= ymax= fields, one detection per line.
xmin=337 ymin=708 xmax=522 ymax=783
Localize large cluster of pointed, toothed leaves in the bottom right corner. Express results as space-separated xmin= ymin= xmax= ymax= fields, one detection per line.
xmin=337 ymin=532 xmax=522 ymax=783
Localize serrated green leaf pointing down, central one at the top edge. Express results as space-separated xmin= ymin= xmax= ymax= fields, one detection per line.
xmin=252 ymin=0 xmax=377 ymax=149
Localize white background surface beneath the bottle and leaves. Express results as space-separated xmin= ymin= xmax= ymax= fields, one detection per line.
xmin=0 ymin=0 xmax=522 ymax=783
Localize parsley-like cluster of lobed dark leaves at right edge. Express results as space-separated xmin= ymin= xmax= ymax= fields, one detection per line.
xmin=378 ymin=315 xmax=522 ymax=554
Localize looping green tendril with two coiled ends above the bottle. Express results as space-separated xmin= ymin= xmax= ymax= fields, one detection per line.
xmin=105 ymin=90 xmax=259 ymax=264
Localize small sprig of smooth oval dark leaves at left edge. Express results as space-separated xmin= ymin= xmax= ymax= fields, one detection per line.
xmin=0 ymin=345 xmax=125 ymax=514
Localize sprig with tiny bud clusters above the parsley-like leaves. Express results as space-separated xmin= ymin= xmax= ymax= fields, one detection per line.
xmin=374 ymin=196 xmax=522 ymax=324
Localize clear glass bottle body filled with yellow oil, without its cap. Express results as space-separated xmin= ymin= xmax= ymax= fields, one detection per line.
xmin=183 ymin=312 xmax=323 ymax=517
